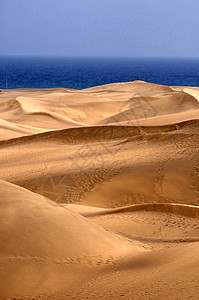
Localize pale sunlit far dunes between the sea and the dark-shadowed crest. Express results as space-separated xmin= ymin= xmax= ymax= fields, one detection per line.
xmin=0 ymin=81 xmax=198 ymax=140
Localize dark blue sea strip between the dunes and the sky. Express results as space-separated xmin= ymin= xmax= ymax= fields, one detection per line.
xmin=0 ymin=56 xmax=199 ymax=89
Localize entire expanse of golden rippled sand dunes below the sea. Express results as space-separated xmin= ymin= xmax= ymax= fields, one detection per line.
xmin=0 ymin=81 xmax=199 ymax=300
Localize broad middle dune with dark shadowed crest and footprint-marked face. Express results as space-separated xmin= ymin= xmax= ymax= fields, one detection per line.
xmin=0 ymin=121 xmax=199 ymax=208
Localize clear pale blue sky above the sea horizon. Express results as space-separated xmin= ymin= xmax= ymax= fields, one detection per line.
xmin=0 ymin=0 xmax=199 ymax=57
